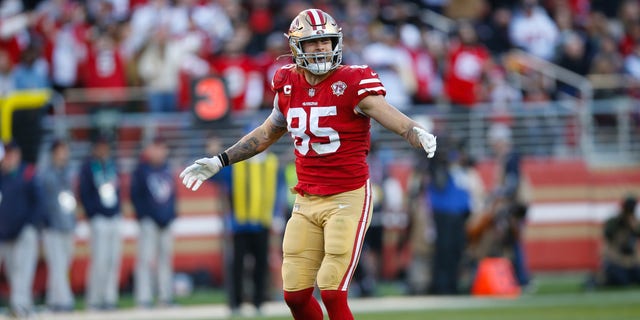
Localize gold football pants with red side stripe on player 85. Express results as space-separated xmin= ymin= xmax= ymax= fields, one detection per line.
xmin=282 ymin=180 xmax=371 ymax=291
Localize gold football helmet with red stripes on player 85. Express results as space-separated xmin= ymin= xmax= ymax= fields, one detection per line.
xmin=285 ymin=9 xmax=342 ymax=75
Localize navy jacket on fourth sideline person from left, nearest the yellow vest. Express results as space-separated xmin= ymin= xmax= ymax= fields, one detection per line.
xmin=131 ymin=161 xmax=176 ymax=228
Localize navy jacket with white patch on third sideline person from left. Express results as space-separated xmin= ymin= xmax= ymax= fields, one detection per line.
xmin=78 ymin=158 xmax=120 ymax=219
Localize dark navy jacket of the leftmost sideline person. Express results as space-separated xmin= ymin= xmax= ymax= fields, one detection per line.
xmin=0 ymin=165 xmax=43 ymax=241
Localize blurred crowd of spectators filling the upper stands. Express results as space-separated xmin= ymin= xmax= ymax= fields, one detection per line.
xmin=0 ymin=0 xmax=640 ymax=112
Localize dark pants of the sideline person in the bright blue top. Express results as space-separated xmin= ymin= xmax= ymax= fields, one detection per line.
xmin=431 ymin=212 xmax=466 ymax=294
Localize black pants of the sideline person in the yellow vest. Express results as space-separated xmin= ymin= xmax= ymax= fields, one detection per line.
xmin=229 ymin=229 xmax=269 ymax=309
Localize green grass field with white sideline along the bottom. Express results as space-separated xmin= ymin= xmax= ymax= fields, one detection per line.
xmin=5 ymin=273 xmax=640 ymax=320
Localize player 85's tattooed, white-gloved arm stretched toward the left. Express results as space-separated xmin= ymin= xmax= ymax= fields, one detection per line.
xmin=180 ymin=118 xmax=287 ymax=191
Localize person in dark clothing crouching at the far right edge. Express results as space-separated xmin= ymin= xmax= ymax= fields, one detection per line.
xmin=603 ymin=195 xmax=640 ymax=286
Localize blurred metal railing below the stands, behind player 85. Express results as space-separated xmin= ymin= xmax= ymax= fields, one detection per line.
xmin=37 ymin=90 xmax=640 ymax=171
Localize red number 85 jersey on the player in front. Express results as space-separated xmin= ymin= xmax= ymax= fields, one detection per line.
xmin=272 ymin=64 xmax=386 ymax=195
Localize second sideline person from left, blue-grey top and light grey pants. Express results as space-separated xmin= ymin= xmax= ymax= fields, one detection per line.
xmin=40 ymin=140 xmax=77 ymax=312
